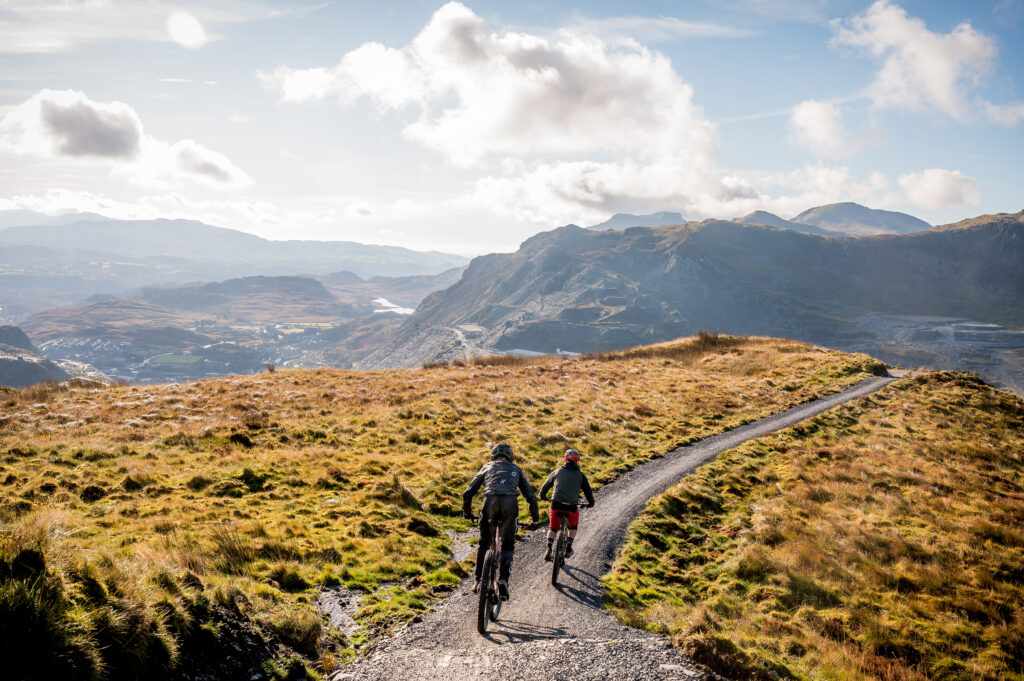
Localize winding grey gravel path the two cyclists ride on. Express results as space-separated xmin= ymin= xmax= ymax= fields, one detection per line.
xmin=331 ymin=377 xmax=895 ymax=681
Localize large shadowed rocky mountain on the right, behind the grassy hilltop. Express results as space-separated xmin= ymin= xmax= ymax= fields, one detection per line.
xmin=358 ymin=213 xmax=1024 ymax=368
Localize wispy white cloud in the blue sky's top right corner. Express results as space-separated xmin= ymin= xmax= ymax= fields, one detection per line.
xmin=831 ymin=0 xmax=1015 ymax=121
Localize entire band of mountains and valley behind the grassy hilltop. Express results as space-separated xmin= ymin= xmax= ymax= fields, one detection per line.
xmin=6 ymin=203 xmax=1024 ymax=386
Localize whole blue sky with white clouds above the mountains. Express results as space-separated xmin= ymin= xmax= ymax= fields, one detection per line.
xmin=0 ymin=0 xmax=1024 ymax=255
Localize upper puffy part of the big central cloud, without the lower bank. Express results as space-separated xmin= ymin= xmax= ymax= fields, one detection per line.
xmin=263 ymin=2 xmax=717 ymax=165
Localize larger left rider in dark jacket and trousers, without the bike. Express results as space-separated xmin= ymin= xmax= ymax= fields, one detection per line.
xmin=462 ymin=442 xmax=540 ymax=600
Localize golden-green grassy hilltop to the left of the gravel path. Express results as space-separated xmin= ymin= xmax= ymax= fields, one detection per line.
xmin=0 ymin=336 xmax=880 ymax=679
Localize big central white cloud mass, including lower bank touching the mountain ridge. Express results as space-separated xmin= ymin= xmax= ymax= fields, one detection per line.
xmin=261 ymin=2 xmax=751 ymax=224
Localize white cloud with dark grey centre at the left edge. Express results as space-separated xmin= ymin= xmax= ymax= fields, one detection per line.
xmin=0 ymin=90 xmax=252 ymax=188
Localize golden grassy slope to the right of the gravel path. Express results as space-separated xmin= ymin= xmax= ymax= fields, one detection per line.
xmin=606 ymin=374 xmax=1024 ymax=681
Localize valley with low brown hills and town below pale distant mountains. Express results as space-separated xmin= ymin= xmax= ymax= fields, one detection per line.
xmin=14 ymin=268 xmax=462 ymax=381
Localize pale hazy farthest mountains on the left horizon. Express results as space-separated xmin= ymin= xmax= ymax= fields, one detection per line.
xmin=0 ymin=211 xmax=467 ymax=321
